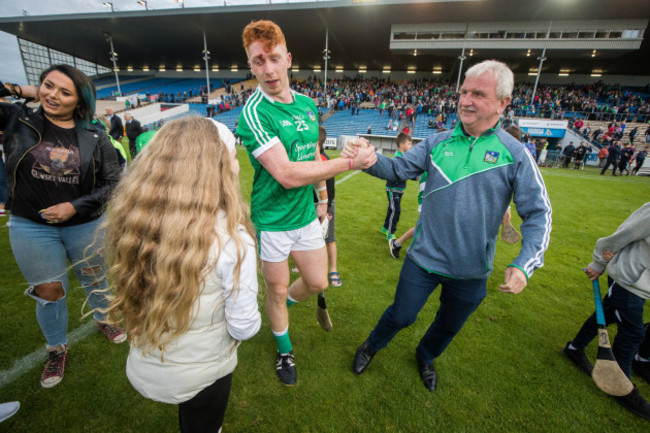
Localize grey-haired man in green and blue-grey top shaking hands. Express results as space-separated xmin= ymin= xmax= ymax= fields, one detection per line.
xmin=342 ymin=60 xmax=551 ymax=391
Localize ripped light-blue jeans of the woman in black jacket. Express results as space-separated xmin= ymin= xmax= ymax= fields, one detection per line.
xmin=9 ymin=215 xmax=109 ymax=347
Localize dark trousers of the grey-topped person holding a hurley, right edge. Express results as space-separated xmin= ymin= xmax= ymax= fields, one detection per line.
xmin=571 ymin=278 xmax=645 ymax=377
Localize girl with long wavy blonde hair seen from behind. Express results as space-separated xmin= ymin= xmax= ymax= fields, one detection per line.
xmin=105 ymin=117 xmax=261 ymax=432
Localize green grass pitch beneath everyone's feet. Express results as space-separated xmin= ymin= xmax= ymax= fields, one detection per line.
xmin=0 ymin=151 xmax=650 ymax=433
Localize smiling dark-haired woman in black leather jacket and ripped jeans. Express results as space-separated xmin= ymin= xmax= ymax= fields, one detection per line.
xmin=0 ymin=65 xmax=126 ymax=388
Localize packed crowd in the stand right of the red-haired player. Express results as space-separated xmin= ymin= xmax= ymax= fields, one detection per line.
xmin=272 ymin=77 xmax=650 ymax=173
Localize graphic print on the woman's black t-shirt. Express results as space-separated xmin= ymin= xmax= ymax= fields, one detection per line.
xmin=30 ymin=141 xmax=80 ymax=185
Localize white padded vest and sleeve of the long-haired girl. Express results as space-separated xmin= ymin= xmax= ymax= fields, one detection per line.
xmin=126 ymin=218 xmax=262 ymax=404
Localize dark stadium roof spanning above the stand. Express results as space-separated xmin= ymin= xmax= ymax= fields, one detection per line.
xmin=0 ymin=0 xmax=650 ymax=78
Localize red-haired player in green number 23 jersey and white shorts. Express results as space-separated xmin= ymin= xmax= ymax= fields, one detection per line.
xmin=237 ymin=20 xmax=377 ymax=385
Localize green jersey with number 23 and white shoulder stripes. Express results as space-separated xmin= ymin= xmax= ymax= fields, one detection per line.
xmin=237 ymin=87 xmax=318 ymax=231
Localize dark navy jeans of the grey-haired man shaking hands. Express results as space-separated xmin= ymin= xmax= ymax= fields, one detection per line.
xmin=369 ymin=255 xmax=487 ymax=363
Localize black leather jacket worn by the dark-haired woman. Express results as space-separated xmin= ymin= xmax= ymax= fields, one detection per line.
xmin=0 ymin=103 xmax=120 ymax=218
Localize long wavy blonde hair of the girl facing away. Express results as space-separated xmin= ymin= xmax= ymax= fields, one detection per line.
xmin=104 ymin=117 xmax=255 ymax=352
